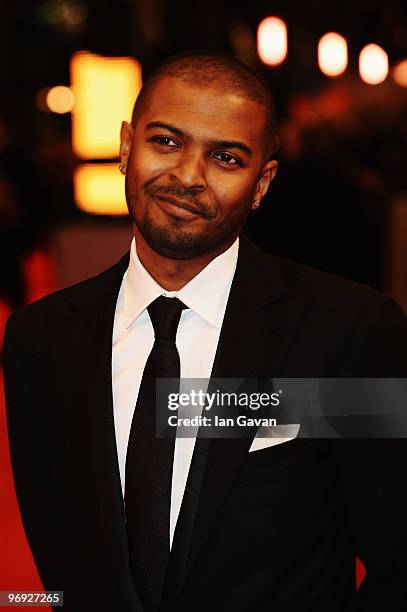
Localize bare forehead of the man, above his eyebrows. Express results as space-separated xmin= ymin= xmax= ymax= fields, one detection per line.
xmin=136 ymin=77 xmax=265 ymax=151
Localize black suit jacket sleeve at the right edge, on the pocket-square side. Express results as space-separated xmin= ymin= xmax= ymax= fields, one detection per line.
xmin=334 ymin=297 xmax=407 ymax=612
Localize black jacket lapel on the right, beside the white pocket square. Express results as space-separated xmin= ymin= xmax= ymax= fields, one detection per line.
xmin=163 ymin=237 xmax=306 ymax=609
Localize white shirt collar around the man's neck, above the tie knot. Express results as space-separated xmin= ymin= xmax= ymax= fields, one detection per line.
xmin=123 ymin=238 xmax=239 ymax=329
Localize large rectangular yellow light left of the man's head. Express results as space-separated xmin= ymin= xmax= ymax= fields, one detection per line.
xmin=71 ymin=51 xmax=141 ymax=159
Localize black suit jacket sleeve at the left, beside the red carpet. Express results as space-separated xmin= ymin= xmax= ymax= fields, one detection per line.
xmin=4 ymin=313 xmax=64 ymax=591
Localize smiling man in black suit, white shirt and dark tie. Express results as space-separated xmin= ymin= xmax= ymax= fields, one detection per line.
xmin=5 ymin=53 xmax=407 ymax=612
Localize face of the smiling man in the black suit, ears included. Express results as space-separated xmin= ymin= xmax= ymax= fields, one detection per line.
xmin=121 ymin=77 xmax=277 ymax=259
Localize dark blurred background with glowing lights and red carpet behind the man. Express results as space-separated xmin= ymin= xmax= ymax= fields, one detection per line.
xmin=0 ymin=0 xmax=407 ymax=604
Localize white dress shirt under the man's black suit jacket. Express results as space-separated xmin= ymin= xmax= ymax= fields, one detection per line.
xmin=112 ymin=238 xmax=239 ymax=546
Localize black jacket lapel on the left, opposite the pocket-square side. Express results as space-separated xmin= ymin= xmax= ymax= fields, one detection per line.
xmin=71 ymin=253 xmax=147 ymax=612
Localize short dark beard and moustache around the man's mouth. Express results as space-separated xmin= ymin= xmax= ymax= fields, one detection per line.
xmin=126 ymin=175 xmax=250 ymax=260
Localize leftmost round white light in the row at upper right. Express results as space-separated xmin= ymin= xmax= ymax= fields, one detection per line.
xmin=257 ymin=17 xmax=287 ymax=66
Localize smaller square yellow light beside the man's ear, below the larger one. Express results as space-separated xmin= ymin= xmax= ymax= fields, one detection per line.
xmin=74 ymin=163 xmax=127 ymax=215
